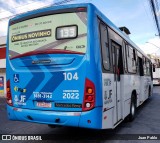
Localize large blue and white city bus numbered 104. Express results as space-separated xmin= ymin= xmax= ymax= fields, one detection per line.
xmin=6 ymin=3 xmax=153 ymax=129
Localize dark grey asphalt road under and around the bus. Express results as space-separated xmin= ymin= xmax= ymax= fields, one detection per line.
xmin=0 ymin=86 xmax=160 ymax=143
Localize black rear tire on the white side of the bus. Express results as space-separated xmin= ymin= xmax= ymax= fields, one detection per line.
xmin=129 ymin=96 xmax=136 ymax=122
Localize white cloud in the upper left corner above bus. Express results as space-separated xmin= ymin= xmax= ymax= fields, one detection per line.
xmin=0 ymin=0 xmax=54 ymax=36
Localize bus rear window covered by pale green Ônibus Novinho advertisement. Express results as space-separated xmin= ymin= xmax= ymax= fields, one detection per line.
xmin=9 ymin=12 xmax=87 ymax=59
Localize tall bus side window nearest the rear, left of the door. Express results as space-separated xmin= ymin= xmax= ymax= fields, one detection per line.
xmin=100 ymin=22 xmax=111 ymax=71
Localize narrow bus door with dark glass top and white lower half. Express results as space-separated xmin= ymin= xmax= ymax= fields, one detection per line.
xmin=112 ymin=42 xmax=122 ymax=122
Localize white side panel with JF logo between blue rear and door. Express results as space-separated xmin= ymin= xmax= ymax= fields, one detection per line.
xmin=102 ymin=73 xmax=115 ymax=129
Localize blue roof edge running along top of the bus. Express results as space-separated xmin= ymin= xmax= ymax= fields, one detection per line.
xmin=9 ymin=3 xmax=150 ymax=59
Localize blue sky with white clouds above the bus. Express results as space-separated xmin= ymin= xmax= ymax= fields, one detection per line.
xmin=0 ymin=0 xmax=160 ymax=55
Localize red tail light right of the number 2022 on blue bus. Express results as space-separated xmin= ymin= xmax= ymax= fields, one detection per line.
xmin=82 ymin=78 xmax=95 ymax=111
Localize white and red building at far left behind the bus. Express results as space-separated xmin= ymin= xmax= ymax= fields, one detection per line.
xmin=0 ymin=37 xmax=6 ymax=94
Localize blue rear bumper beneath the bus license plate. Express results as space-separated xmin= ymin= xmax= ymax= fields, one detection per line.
xmin=7 ymin=105 xmax=102 ymax=129
